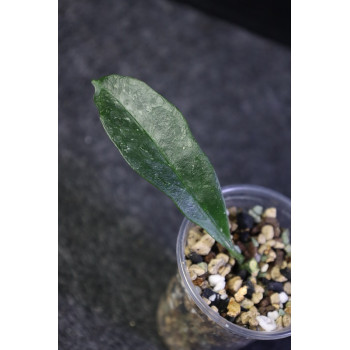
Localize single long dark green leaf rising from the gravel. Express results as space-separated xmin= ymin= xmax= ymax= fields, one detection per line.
xmin=92 ymin=75 xmax=243 ymax=262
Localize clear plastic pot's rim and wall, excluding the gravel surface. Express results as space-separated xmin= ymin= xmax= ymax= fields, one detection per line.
xmin=157 ymin=185 xmax=291 ymax=350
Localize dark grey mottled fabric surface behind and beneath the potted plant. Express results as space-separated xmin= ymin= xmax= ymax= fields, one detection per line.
xmin=59 ymin=0 xmax=290 ymax=350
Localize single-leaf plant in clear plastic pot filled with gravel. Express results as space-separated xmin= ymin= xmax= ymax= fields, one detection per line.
xmin=92 ymin=75 xmax=291 ymax=349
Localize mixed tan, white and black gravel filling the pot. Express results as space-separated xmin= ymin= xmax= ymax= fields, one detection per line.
xmin=185 ymin=205 xmax=291 ymax=332
